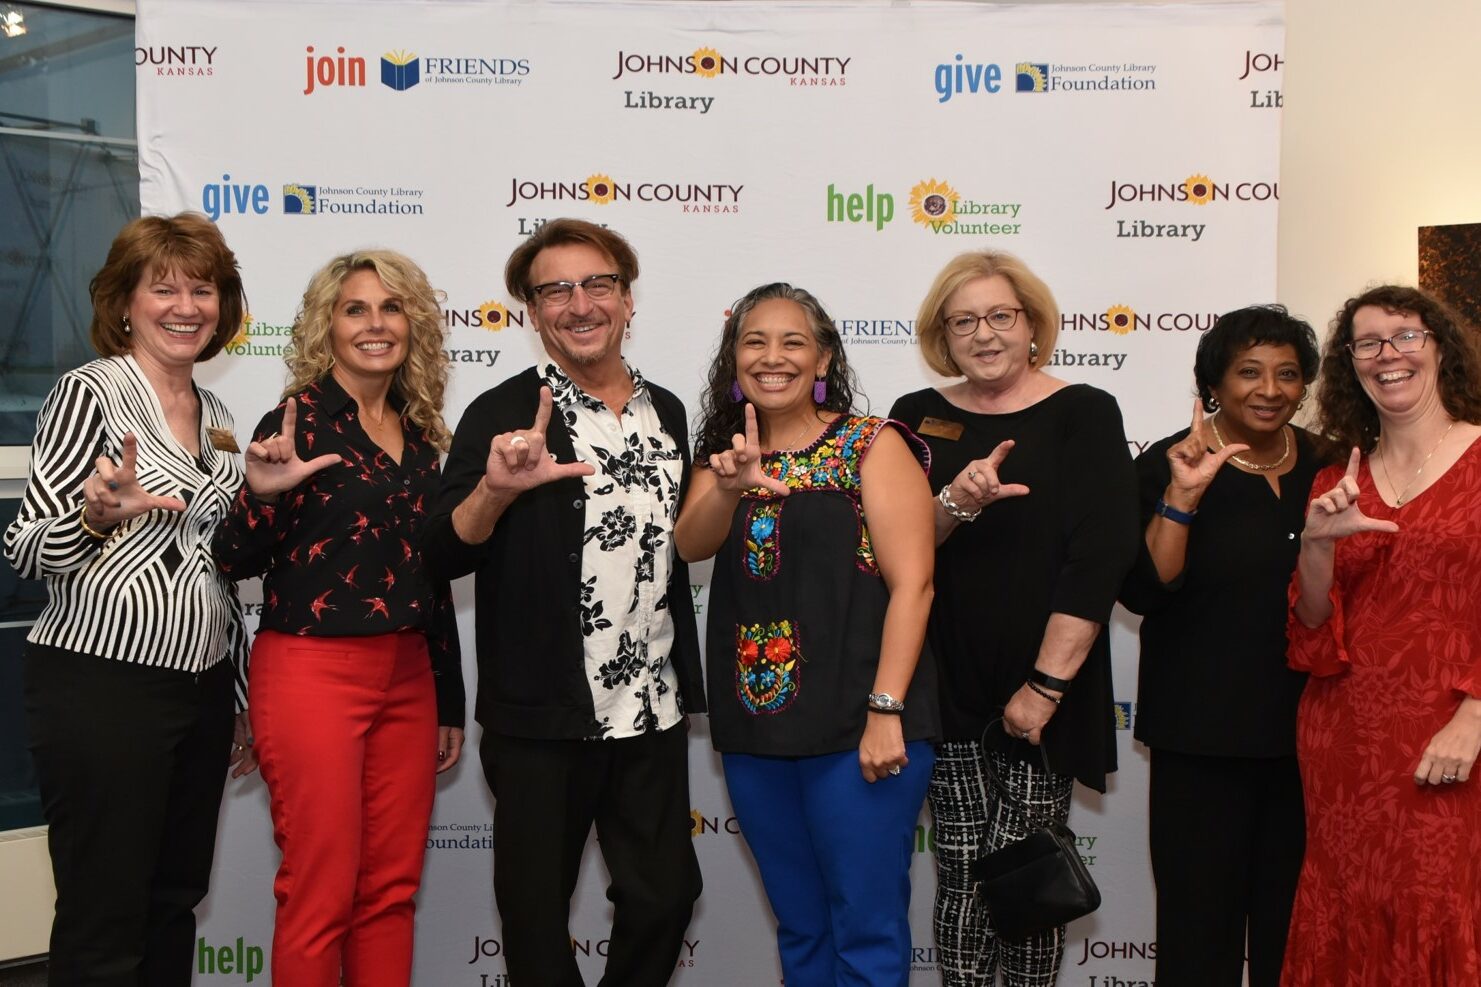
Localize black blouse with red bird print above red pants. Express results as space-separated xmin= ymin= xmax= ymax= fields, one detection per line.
xmin=212 ymin=375 xmax=464 ymax=728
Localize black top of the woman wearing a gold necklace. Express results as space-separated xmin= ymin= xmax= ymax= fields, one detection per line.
xmin=1121 ymin=428 xmax=1325 ymax=757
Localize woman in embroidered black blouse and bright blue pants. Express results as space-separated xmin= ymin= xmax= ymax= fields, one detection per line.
xmin=674 ymin=283 xmax=937 ymax=987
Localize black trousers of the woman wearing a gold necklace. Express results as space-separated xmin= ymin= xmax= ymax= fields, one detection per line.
xmin=1148 ymin=748 xmax=1306 ymax=987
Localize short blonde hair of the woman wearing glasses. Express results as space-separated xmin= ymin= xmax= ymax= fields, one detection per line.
xmin=915 ymin=250 xmax=1059 ymax=376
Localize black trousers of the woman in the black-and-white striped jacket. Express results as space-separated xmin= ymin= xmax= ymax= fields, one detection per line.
xmin=25 ymin=645 xmax=233 ymax=987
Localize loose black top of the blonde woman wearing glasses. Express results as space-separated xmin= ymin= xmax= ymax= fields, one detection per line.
xmin=890 ymin=384 xmax=1137 ymax=791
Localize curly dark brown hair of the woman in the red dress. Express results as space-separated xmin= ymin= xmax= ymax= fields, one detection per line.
xmin=1315 ymin=285 xmax=1481 ymax=452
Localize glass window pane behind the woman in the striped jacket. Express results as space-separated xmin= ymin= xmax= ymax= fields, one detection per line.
xmin=0 ymin=3 xmax=139 ymax=446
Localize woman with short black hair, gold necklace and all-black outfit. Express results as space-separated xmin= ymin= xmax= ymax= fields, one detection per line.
xmin=1121 ymin=305 xmax=1324 ymax=987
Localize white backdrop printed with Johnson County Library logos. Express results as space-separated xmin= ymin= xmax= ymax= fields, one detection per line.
xmin=133 ymin=0 xmax=1283 ymax=987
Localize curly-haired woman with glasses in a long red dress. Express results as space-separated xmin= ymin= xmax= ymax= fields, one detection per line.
xmin=1281 ymin=286 xmax=1481 ymax=987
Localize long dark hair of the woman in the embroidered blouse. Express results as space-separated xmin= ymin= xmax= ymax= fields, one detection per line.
xmin=695 ymin=282 xmax=857 ymax=459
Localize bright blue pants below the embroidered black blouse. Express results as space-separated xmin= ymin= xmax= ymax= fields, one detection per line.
xmin=723 ymin=741 xmax=936 ymax=987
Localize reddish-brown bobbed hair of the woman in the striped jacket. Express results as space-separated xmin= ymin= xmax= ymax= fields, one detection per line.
xmin=87 ymin=212 xmax=247 ymax=363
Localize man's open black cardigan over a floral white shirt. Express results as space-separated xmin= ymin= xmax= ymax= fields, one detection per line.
xmin=424 ymin=368 xmax=705 ymax=740
